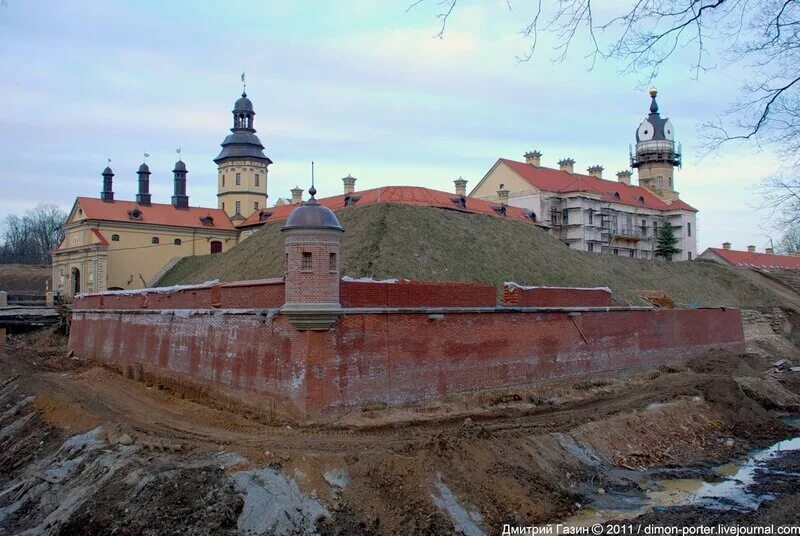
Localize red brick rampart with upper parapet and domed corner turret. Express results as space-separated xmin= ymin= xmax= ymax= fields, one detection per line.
xmin=70 ymin=185 xmax=744 ymax=421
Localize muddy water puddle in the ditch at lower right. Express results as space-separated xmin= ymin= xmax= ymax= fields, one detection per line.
xmin=562 ymin=434 xmax=800 ymax=527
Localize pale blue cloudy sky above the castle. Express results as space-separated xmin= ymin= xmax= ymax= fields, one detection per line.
xmin=0 ymin=0 xmax=780 ymax=250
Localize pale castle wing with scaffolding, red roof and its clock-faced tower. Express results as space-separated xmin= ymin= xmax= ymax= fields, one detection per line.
xmin=472 ymin=88 xmax=697 ymax=261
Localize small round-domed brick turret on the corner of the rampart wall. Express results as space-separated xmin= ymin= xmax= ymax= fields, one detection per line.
xmin=281 ymin=185 xmax=344 ymax=330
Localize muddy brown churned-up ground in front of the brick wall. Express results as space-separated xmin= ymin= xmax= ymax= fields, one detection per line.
xmin=0 ymin=313 xmax=800 ymax=536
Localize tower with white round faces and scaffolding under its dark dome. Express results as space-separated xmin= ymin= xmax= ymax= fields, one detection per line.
xmin=631 ymin=88 xmax=681 ymax=202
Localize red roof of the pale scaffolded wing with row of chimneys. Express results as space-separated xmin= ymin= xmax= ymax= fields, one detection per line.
xmin=499 ymin=158 xmax=697 ymax=212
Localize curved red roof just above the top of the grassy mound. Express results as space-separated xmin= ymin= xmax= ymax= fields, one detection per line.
xmin=239 ymin=186 xmax=548 ymax=227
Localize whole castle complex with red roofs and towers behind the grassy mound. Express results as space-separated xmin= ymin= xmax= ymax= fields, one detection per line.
xmin=52 ymin=89 xmax=697 ymax=298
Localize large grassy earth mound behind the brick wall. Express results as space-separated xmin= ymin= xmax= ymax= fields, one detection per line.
xmin=159 ymin=203 xmax=783 ymax=306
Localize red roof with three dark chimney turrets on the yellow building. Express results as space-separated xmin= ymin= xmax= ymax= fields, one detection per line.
xmin=76 ymin=197 xmax=236 ymax=231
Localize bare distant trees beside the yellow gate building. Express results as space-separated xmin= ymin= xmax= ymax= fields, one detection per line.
xmin=0 ymin=204 xmax=67 ymax=264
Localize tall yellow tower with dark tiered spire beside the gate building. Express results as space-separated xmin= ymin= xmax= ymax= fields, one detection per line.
xmin=214 ymin=92 xmax=272 ymax=223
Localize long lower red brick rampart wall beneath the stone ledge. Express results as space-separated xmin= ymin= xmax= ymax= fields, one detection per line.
xmin=70 ymin=309 xmax=744 ymax=417
